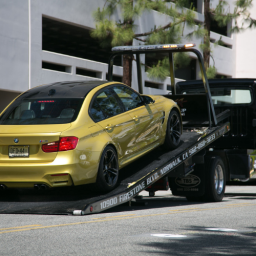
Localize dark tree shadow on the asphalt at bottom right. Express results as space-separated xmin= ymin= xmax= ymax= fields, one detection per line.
xmin=137 ymin=227 xmax=256 ymax=256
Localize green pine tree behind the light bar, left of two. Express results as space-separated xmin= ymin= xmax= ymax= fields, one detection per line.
xmin=91 ymin=0 xmax=198 ymax=85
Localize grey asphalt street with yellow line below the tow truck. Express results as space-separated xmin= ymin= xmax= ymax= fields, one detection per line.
xmin=0 ymin=186 xmax=256 ymax=255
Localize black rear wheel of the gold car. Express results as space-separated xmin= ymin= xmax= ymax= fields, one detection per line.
xmin=96 ymin=146 xmax=119 ymax=192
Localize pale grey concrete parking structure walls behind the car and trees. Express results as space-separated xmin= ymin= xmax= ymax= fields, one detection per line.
xmin=0 ymin=0 xmax=240 ymax=112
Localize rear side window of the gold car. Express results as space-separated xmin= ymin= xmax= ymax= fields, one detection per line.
xmin=90 ymin=89 xmax=123 ymax=122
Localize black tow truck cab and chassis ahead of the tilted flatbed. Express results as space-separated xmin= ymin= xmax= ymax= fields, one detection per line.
xmin=167 ymin=78 xmax=256 ymax=201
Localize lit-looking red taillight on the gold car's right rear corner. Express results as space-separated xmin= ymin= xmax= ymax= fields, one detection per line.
xmin=42 ymin=137 xmax=78 ymax=153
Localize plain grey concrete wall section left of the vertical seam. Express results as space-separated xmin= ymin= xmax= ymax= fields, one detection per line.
xmin=0 ymin=0 xmax=29 ymax=92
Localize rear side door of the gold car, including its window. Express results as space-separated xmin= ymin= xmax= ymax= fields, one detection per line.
xmin=90 ymin=88 xmax=135 ymax=164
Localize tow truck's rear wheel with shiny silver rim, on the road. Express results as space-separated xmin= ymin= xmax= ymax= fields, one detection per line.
xmin=205 ymin=157 xmax=226 ymax=202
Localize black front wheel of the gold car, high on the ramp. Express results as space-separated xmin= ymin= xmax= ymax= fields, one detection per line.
xmin=164 ymin=109 xmax=181 ymax=150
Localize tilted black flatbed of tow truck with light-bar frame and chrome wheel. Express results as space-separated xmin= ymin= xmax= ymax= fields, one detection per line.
xmin=0 ymin=44 xmax=230 ymax=215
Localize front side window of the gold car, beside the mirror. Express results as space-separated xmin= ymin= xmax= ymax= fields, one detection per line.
xmin=113 ymin=86 xmax=144 ymax=111
